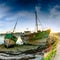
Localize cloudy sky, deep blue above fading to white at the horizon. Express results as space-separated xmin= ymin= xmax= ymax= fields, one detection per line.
xmin=0 ymin=0 xmax=60 ymax=33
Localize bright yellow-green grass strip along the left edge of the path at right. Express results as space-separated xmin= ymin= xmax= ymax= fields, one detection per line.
xmin=44 ymin=37 xmax=58 ymax=60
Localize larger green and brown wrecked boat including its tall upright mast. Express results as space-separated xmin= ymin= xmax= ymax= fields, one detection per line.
xmin=21 ymin=7 xmax=50 ymax=45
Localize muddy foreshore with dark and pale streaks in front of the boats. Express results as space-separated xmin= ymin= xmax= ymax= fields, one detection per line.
xmin=0 ymin=45 xmax=50 ymax=60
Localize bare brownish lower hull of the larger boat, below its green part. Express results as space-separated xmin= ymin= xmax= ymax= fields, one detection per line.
xmin=22 ymin=38 xmax=48 ymax=45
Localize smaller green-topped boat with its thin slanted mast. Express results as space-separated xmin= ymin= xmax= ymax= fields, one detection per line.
xmin=4 ymin=21 xmax=17 ymax=47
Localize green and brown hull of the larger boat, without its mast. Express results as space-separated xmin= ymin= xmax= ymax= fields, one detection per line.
xmin=21 ymin=30 xmax=50 ymax=45
